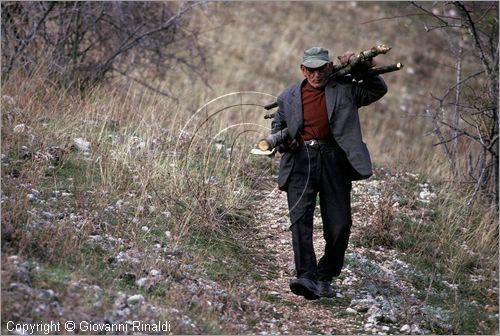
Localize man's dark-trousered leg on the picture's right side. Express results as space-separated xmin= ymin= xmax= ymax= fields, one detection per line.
xmin=318 ymin=149 xmax=352 ymax=282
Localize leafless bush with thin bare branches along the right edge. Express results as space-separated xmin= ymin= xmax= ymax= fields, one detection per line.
xmin=412 ymin=2 xmax=499 ymax=204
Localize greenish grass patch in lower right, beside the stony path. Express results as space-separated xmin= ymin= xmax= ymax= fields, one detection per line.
xmin=396 ymin=194 xmax=498 ymax=334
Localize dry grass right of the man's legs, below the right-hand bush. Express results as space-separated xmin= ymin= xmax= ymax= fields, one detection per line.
xmin=354 ymin=168 xmax=499 ymax=334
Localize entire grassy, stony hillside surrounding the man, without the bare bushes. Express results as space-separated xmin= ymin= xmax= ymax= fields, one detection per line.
xmin=1 ymin=2 xmax=498 ymax=334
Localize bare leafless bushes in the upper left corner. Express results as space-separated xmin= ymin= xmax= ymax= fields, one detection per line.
xmin=2 ymin=1 xmax=211 ymax=93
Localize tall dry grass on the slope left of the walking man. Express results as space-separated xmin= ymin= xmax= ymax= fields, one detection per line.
xmin=2 ymin=65 xmax=268 ymax=333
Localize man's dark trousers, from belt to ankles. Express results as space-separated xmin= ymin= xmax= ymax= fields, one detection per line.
xmin=287 ymin=145 xmax=352 ymax=281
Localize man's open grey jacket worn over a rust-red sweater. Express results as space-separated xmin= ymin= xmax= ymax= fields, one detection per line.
xmin=271 ymin=76 xmax=387 ymax=190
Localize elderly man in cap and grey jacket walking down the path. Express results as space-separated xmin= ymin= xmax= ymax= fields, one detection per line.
xmin=271 ymin=47 xmax=387 ymax=300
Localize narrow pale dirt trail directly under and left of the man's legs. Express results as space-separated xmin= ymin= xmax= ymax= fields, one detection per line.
xmin=250 ymin=182 xmax=362 ymax=334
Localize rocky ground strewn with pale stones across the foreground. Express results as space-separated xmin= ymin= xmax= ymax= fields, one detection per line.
xmin=2 ymin=142 xmax=498 ymax=334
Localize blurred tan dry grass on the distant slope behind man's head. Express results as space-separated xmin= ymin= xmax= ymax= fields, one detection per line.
xmin=185 ymin=2 xmax=465 ymax=184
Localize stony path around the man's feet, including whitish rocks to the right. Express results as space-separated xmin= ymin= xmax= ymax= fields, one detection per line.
xmin=245 ymin=172 xmax=448 ymax=334
